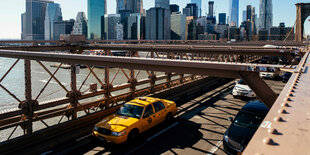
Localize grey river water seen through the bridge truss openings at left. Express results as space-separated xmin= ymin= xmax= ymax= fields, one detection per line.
xmin=0 ymin=53 xmax=170 ymax=142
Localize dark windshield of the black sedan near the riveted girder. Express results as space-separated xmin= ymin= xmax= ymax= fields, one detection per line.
xmin=234 ymin=112 xmax=265 ymax=128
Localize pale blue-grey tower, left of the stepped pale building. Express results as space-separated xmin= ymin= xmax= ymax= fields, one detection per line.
xmin=44 ymin=3 xmax=62 ymax=40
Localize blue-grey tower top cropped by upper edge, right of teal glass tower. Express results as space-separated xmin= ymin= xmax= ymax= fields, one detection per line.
xmin=116 ymin=0 xmax=143 ymax=14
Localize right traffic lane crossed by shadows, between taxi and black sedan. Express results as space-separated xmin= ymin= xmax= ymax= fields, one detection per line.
xmin=131 ymin=83 xmax=246 ymax=154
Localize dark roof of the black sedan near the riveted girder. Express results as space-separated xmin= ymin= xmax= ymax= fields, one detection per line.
xmin=241 ymin=100 xmax=269 ymax=114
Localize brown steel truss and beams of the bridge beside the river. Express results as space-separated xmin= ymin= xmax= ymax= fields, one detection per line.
xmin=0 ymin=42 xmax=304 ymax=154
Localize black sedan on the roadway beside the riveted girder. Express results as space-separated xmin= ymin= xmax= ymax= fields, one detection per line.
xmin=223 ymin=101 xmax=269 ymax=154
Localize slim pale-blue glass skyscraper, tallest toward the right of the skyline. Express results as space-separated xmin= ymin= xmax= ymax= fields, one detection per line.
xmin=229 ymin=0 xmax=239 ymax=26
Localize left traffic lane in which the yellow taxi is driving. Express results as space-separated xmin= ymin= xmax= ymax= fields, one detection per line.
xmin=54 ymin=79 xmax=232 ymax=154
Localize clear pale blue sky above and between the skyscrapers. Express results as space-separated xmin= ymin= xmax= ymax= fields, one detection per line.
xmin=0 ymin=0 xmax=310 ymax=39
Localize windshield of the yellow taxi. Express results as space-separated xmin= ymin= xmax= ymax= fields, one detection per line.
xmin=117 ymin=104 xmax=143 ymax=118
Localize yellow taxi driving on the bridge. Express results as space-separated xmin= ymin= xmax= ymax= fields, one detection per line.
xmin=92 ymin=97 xmax=177 ymax=144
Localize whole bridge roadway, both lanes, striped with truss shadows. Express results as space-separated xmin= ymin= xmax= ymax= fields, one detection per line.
xmin=46 ymin=79 xmax=285 ymax=154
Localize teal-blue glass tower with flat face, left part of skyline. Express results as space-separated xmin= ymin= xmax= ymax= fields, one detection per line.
xmin=87 ymin=0 xmax=107 ymax=39
